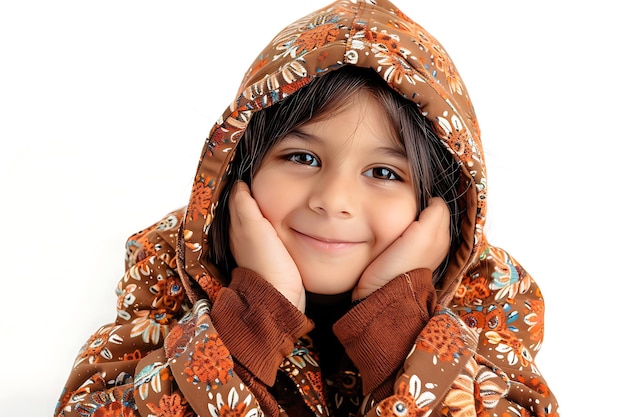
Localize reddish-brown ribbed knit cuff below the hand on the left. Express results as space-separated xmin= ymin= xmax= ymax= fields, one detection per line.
xmin=211 ymin=268 xmax=313 ymax=386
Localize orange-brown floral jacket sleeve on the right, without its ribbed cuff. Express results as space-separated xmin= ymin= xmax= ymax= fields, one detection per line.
xmin=338 ymin=246 xmax=559 ymax=416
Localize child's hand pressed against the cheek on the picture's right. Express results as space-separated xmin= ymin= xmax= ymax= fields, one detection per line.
xmin=352 ymin=197 xmax=450 ymax=300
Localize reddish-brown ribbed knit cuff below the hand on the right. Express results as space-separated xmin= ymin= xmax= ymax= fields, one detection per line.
xmin=333 ymin=269 xmax=436 ymax=394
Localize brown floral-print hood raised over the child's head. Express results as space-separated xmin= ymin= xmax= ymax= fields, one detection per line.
xmin=177 ymin=0 xmax=486 ymax=304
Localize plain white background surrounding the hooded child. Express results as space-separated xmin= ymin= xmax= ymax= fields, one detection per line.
xmin=0 ymin=0 xmax=626 ymax=417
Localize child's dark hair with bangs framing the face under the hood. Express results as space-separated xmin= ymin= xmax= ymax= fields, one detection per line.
xmin=208 ymin=66 xmax=464 ymax=283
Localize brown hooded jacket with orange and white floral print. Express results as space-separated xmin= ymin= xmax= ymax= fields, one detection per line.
xmin=55 ymin=0 xmax=558 ymax=417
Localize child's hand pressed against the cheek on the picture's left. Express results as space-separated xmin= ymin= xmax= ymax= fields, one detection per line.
xmin=228 ymin=181 xmax=305 ymax=312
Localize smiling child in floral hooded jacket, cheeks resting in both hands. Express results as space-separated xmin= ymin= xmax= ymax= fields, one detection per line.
xmin=56 ymin=0 xmax=558 ymax=416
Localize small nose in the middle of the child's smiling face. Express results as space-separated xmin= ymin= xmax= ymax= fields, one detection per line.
xmin=309 ymin=173 xmax=358 ymax=219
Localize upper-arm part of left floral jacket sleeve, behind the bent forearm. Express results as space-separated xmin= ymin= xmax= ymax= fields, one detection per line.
xmin=55 ymin=209 xmax=187 ymax=416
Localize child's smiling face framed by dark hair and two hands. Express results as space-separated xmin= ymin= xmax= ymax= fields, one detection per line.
xmin=252 ymin=94 xmax=417 ymax=294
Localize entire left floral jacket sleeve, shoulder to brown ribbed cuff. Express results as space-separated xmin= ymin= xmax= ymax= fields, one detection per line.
xmin=55 ymin=210 xmax=312 ymax=417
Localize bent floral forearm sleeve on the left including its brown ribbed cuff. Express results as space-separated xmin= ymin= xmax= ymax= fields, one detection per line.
xmin=135 ymin=268 xmax=311 ymax=416
